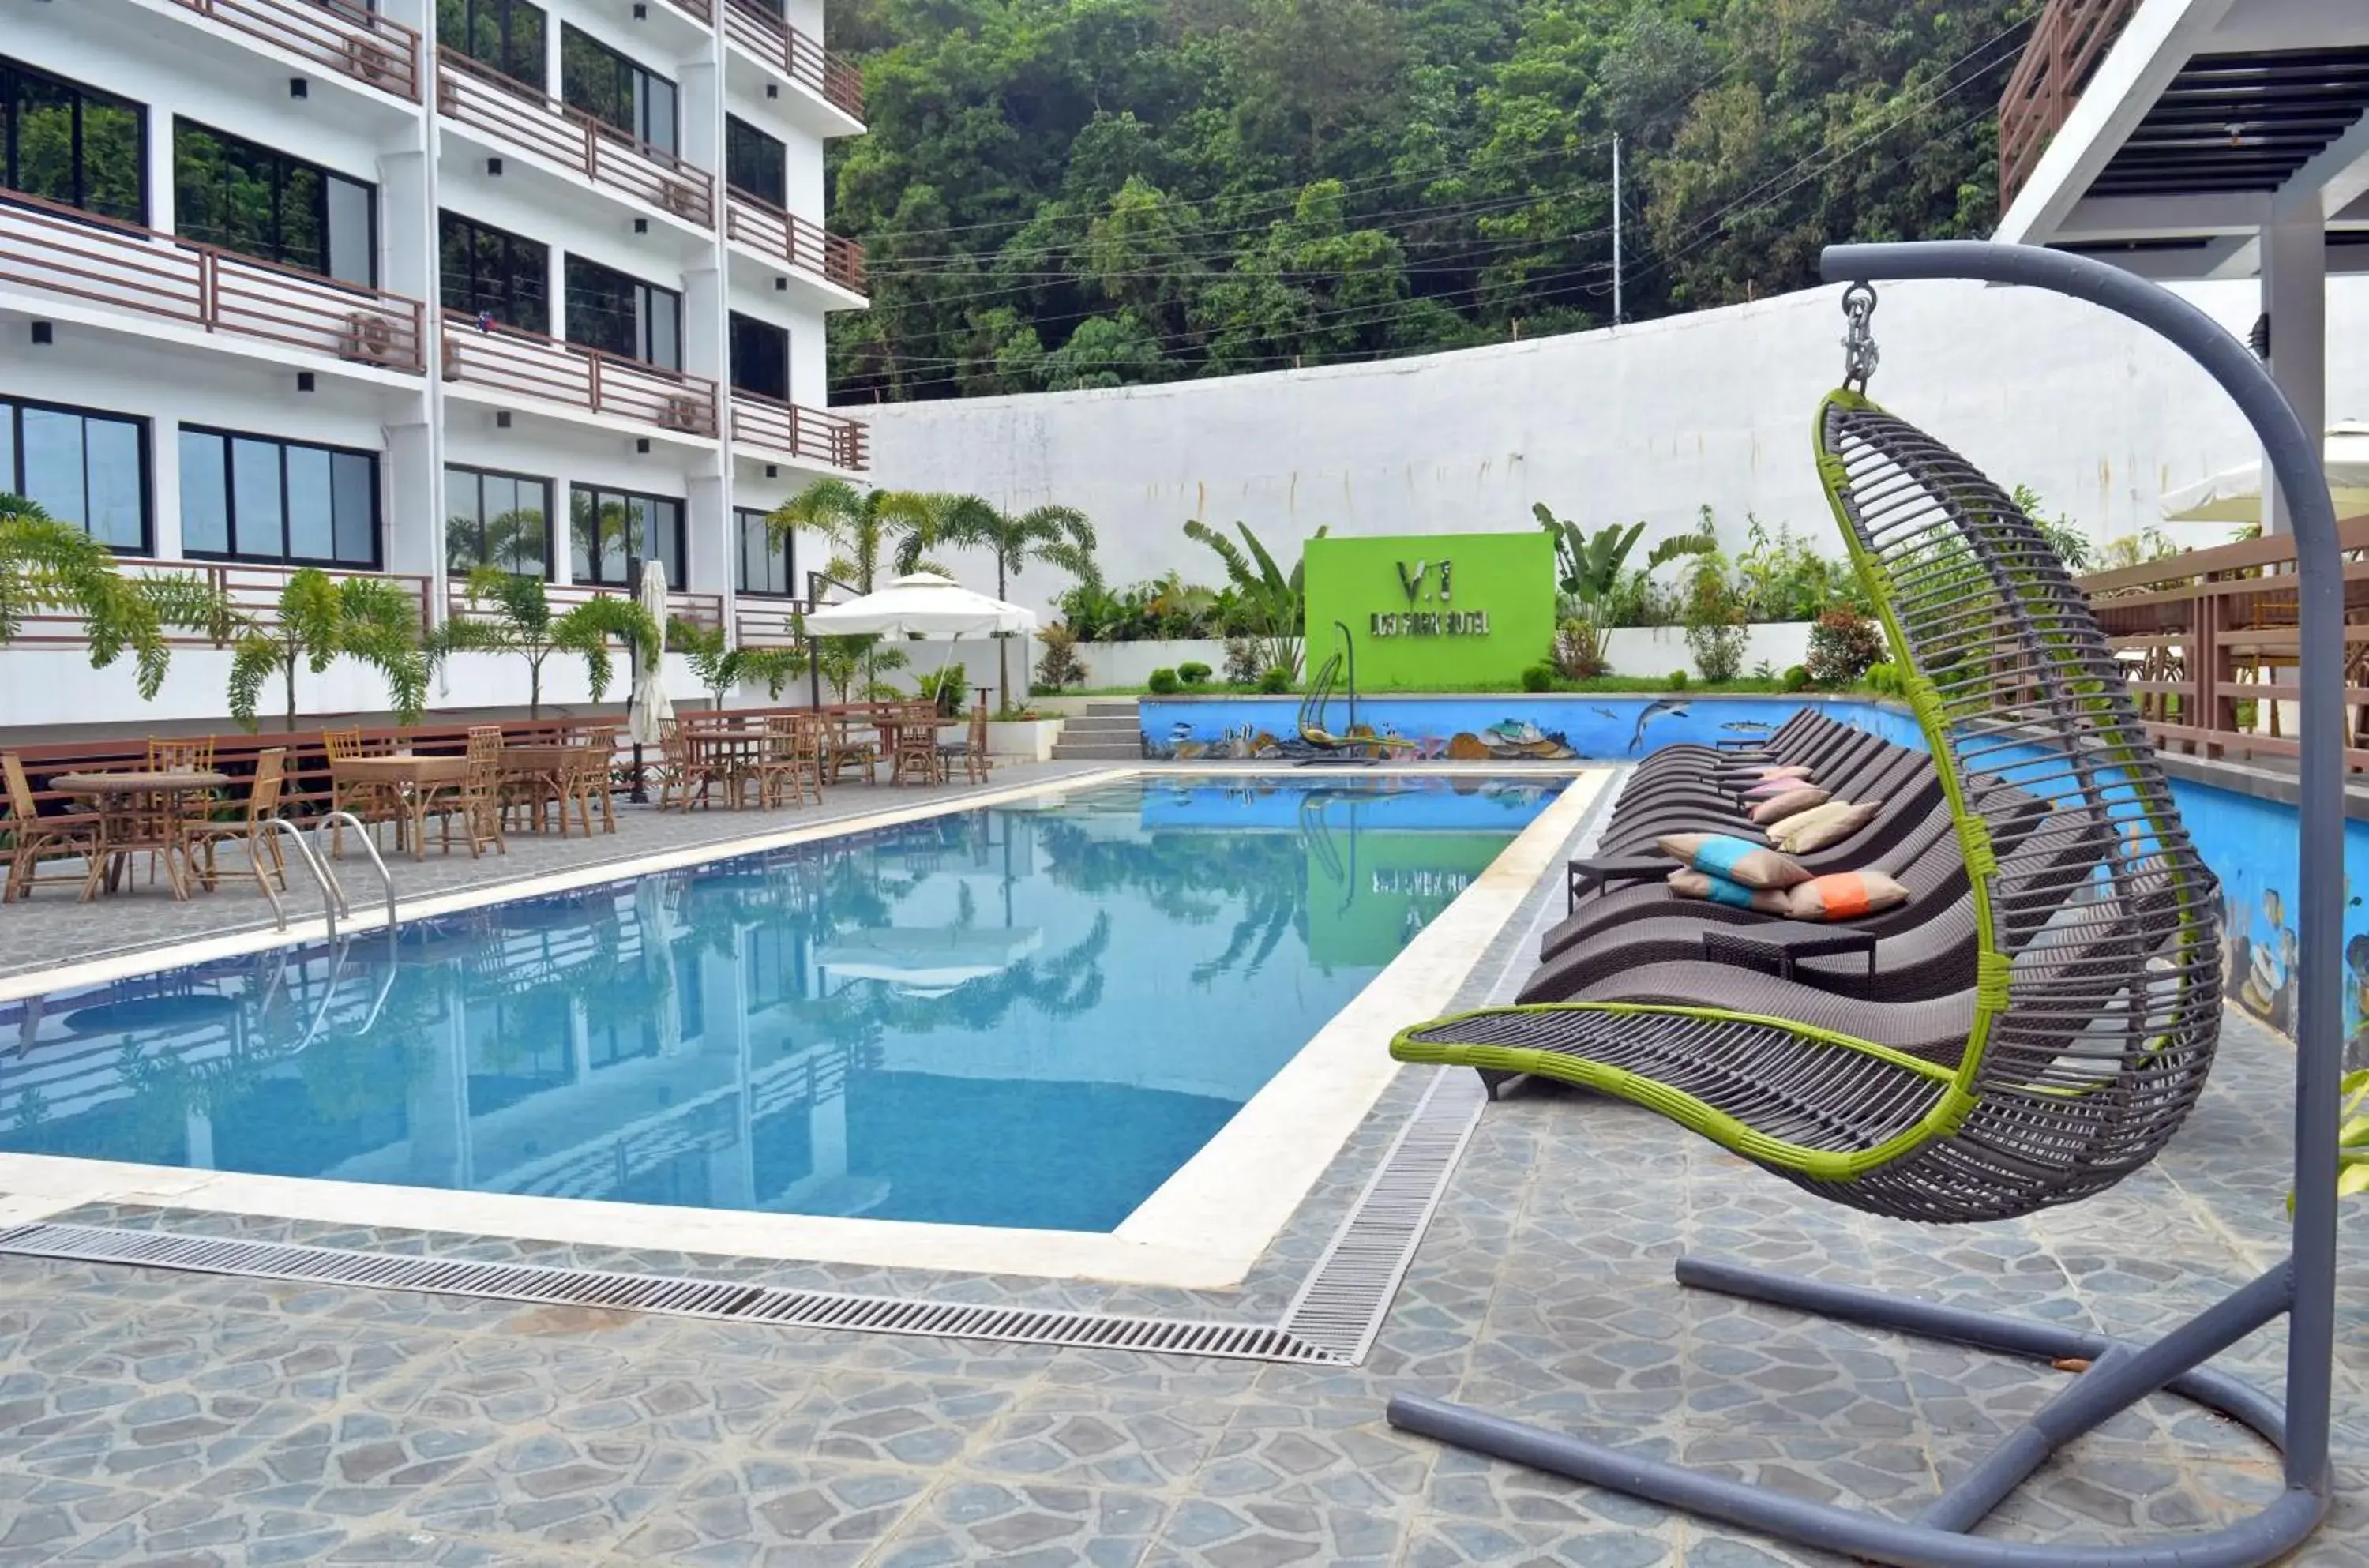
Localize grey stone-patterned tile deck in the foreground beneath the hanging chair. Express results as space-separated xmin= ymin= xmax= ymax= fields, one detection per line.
xmin=0 ymin=775 xmax=2369 ymax=1568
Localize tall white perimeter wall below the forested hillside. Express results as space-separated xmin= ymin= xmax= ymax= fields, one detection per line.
xmin=848 ymin=277 xmax=2369 ymax=606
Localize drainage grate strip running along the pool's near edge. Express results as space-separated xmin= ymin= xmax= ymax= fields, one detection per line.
xmin=0 ymin=1222 xmax=1379 ymax=1364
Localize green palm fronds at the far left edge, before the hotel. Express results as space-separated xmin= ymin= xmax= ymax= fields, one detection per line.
xmin=0 ymin=490 xmax=230 ymax=699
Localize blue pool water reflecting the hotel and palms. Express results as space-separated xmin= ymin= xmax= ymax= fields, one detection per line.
xmin=0 ymin=777 xmax=1564 ymax=1232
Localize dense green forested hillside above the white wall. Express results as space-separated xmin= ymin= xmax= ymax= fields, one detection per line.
xmin=829 ymin=0 xmax=2040 ymax=403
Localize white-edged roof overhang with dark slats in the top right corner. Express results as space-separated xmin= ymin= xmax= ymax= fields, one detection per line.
xmin=1997 ymin=0 xmax=2369 ymax=282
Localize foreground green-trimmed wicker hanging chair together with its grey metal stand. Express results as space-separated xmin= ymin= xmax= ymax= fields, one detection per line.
xmin=1388 ymin=242 xmax=2343 ymax=1568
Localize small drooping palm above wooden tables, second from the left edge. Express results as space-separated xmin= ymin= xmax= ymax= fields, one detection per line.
xmin=230 ymin=566 xmax=429 ymax=730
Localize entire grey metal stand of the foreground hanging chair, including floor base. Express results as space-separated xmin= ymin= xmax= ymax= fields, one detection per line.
xmin=1388 ymin=242 xmax=2345 ymax=1568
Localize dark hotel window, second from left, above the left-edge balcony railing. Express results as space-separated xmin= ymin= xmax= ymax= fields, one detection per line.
xmin=173 ymin=121 xmax=379 ymax=287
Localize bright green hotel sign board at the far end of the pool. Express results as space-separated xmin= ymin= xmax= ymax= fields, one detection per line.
xmin=1305 ymin=528 xmax=1554 ymax=692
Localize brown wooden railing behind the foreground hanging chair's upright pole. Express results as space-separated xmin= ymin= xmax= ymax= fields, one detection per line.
xmin=2075 ymin=516 xmax=2369 ymax=770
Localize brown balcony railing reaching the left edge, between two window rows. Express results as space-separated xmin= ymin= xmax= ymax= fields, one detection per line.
xmin=0 ymin=189 xmax=426 ymax=372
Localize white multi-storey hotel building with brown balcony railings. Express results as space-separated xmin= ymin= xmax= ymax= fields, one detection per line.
xmin=0 ymin=0 xmax=867 ymax=730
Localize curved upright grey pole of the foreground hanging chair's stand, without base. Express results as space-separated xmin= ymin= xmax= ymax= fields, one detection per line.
xmin=1819 ymin=239 xmax=2345 ymax=1495
